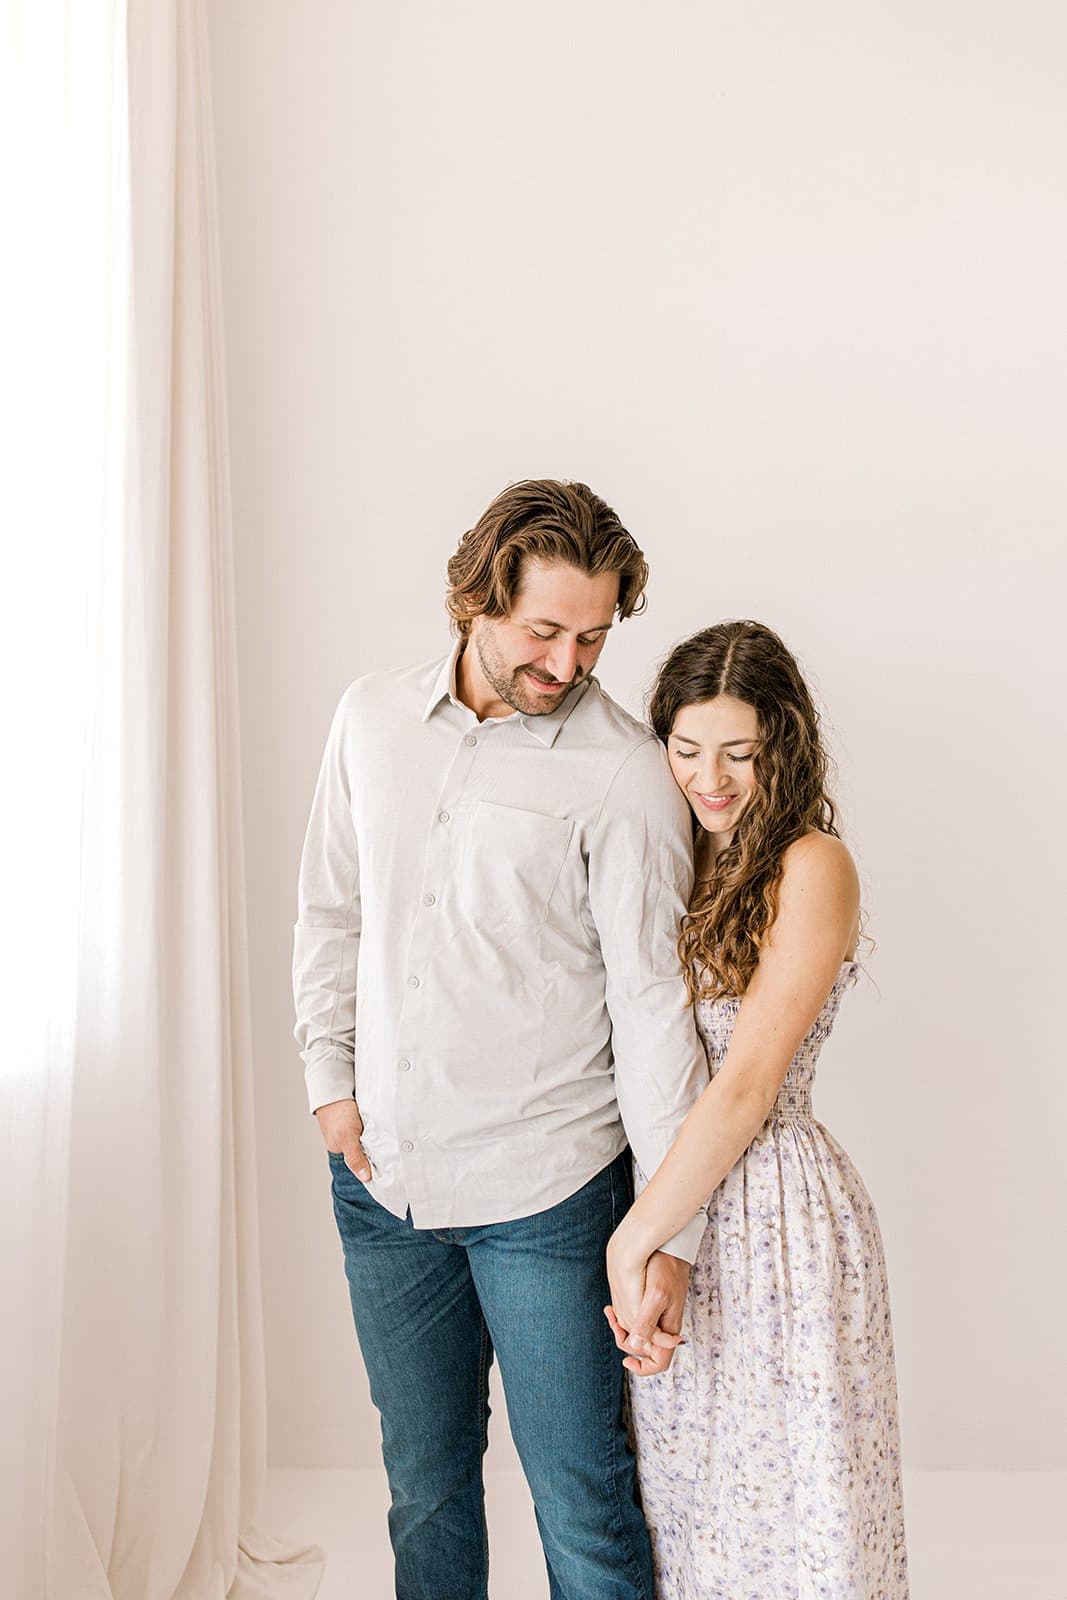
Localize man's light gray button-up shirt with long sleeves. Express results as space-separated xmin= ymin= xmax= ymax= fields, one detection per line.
xmin=293 ymin=650 xmax=707 ymax=1261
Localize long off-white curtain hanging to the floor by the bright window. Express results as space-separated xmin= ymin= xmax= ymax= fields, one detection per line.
xmin=5 ymin=0 xmax=322 ymax=1600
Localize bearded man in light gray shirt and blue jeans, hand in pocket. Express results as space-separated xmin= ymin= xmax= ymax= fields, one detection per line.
xmin=294 ymin=480 xmax=707 ymax=1600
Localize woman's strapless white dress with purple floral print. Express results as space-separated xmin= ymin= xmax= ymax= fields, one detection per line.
xmin=630 ymin=962 xmax=907 ymax=1600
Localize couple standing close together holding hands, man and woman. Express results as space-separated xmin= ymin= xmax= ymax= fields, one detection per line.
xmin=294 ymin=480 xmax=907 ymax=1600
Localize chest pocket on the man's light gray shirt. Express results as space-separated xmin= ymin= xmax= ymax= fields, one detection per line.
xmin=459 ymin=800 xmax=574 ymax=931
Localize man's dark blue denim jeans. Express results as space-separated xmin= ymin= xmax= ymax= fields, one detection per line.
xmin=330 ymin=1155 xmax=653 ymax=1600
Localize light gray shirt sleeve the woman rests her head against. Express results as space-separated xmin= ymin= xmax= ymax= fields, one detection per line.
xmin=589 ymin=738 xmax=709 ymax=1262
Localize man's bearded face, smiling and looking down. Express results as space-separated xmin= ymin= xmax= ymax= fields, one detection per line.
xmin=469 ymin=557 xmax=619 ymax=717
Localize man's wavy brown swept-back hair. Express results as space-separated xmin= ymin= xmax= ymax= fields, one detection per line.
xmin=445 ymin=478 xmax=648 ymax=638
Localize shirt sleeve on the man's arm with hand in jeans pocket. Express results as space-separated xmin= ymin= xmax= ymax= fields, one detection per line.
xmin=293 ymin=691 xmax=360 ymax=1112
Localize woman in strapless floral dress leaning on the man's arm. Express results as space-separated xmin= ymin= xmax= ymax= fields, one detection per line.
xmin=608 ymin=622 xmax=907 ymax=1600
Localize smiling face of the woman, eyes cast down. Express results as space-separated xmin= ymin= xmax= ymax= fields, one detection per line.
xmin=667 ymin=694 xmax=760 ymax=845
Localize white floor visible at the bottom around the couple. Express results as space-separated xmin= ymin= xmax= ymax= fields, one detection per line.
xmin=262 ymin=1467 xmax=1067 ymax=1600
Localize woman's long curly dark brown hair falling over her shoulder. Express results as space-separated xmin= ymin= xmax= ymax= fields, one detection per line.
xmin=648 ymin=622 xmax=838 ymax=1000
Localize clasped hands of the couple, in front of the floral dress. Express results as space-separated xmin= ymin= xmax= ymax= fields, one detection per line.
xmin=605 ymin=1224 xmax=689 ymax=1378
